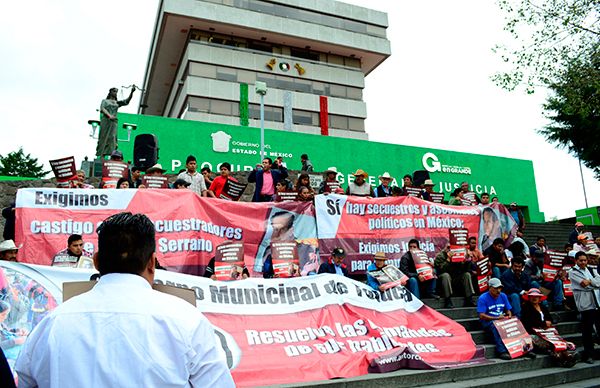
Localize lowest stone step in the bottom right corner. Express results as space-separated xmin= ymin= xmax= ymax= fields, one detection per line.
xmin=421 ymin=363 xmax=600 ymax=388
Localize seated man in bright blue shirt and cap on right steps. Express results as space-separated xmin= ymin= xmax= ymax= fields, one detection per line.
xmin=477 ymin=278 xmax=512 ymax=360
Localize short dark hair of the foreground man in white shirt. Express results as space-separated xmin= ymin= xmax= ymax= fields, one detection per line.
xmin=96 ymin=213 xmax=156 ymax=275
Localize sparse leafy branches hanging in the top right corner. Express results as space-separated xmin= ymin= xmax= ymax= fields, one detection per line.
xmin=492 ymin=0 xmax=600 ymax=93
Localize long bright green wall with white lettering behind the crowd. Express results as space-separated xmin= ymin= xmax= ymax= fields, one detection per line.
xmin=119 ymin=113 xmax=544 ymax=222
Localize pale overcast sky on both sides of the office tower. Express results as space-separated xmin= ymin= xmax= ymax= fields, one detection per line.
xmin=0 ymin=0 xmax=600 ymax=219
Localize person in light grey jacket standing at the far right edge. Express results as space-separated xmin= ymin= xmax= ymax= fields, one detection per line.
xmin=569 ymin=252 xmax=600 ymax=364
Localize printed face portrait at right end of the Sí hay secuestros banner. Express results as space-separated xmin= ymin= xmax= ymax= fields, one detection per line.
xmin=478 ymin=203 xmax=518 ymax=252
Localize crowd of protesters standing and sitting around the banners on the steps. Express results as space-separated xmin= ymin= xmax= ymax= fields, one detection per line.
xmin=0 ymin=151 xmax=600 ymax=376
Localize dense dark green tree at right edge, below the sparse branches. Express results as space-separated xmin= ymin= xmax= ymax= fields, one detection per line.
xmin=539 ymin=46 xmax=600 ymax=179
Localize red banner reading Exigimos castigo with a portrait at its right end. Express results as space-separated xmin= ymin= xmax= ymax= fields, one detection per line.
xmin=16 ymin=188 xmax=320 ymax=275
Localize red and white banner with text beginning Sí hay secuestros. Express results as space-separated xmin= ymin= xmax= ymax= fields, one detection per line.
xmin=315 ymin=194 xmax=481 ymax=274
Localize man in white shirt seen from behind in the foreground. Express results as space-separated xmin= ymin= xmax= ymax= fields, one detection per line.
xmin=16 ymin=213 xmax=234 ymax=388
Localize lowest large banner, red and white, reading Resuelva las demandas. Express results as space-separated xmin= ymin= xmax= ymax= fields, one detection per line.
xmin=0 ymin=262 xmax=486 ymax=387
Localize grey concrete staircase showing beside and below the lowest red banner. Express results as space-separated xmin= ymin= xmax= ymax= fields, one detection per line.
xmin=282 ymin=297 xmax=600 ymax=388
